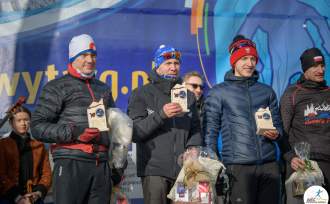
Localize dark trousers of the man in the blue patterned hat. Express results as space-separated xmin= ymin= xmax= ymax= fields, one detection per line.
xmin=141 ymin=176 xmax=175 ymax=204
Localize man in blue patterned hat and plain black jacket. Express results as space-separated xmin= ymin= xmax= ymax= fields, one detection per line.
xmin=128 ymin=45 xmax=202 ymax=204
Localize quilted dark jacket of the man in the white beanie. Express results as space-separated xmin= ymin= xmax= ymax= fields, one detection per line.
xmin=31 ymin=68 xmax=115 ymax=161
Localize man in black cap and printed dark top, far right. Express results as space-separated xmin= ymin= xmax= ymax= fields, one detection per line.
xmin=280 ymin=48 xmax=330 ymax=192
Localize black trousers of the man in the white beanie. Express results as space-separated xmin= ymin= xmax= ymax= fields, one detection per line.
xmin=53 ymin=159 xmax=111 ymax=204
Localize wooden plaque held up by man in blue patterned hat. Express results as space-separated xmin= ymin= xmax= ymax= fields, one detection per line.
xmin=171 ymin=84 xmax=189 ymax=112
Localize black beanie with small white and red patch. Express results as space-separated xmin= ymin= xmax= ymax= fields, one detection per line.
xmin=300 ymin=48 xmax=324 ymax=72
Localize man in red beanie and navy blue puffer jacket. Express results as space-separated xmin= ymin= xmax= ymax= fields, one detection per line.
xmin=203 ymin=35 xmax=282 ymax=204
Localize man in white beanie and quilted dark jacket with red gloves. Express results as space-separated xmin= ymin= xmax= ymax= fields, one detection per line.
xmin=31 ymin=34 xmax=115 ymax=204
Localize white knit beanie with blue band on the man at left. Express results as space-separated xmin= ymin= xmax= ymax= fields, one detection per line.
xmin=69 ymin=34 xmax=96 ymax=63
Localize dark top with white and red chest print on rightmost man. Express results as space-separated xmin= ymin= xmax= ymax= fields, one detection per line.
xmin=280 ymin=75 xmax=330 ymax=162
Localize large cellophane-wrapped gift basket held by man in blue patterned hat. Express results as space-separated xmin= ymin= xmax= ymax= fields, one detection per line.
xmin=167 ymin=147 xmax=224 ymax=204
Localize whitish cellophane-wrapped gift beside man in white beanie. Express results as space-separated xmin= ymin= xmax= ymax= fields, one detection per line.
xmin=107 ymin=108 xmax=133 ymax=169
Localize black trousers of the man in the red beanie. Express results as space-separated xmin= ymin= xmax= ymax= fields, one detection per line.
xmin=227 ymin=162 xmax=281 ymax=204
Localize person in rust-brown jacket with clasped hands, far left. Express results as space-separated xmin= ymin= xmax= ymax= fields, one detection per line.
xmin=0 ymin=106 xmax=52 ymax=204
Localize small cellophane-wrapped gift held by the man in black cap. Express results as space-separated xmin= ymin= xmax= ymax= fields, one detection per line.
xmin=285 ymin=142 xmax=324 ymax=197
